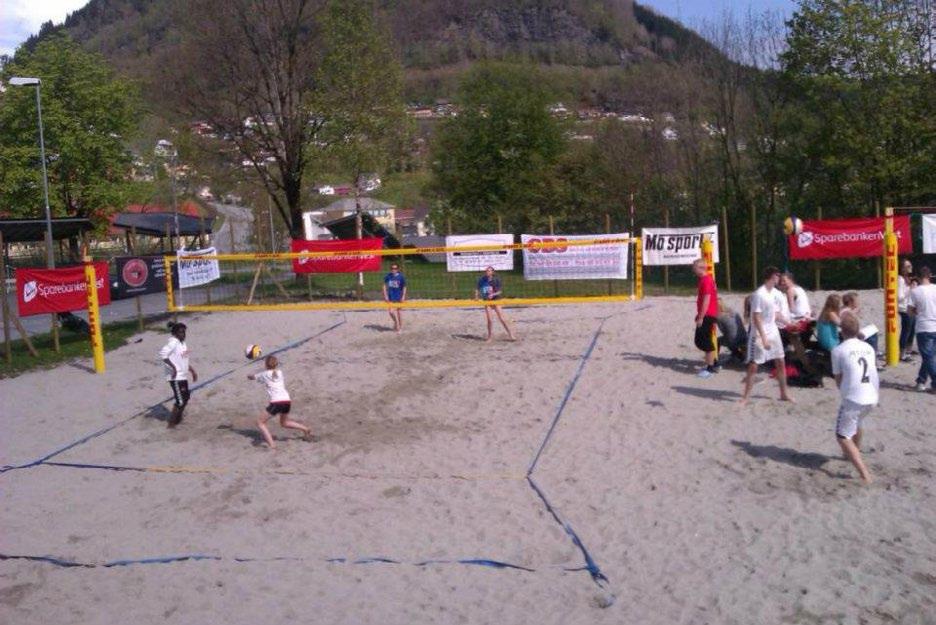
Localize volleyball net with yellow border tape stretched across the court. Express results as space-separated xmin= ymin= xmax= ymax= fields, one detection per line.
xmin=164 ymin=235 xmax=643 ymax=312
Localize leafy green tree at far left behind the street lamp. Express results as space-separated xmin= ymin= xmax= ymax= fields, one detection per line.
xmin=0 ymin=35 xmax=139 ymax=222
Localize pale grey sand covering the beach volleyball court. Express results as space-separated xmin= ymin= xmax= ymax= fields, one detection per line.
xmin=0 ymin=292 xmax=936 ymax=625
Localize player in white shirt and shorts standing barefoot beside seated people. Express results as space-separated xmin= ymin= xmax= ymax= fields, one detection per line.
xmin=741 ymin=267 xmax=793 ymax=404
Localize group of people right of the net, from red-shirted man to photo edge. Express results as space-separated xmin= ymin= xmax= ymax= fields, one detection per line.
xmin=693 ymin=259 xmax=936 ymax=482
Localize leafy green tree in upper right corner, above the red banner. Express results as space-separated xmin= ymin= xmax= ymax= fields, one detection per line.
xmin=781 ymin=0 xmax=936 ymax=214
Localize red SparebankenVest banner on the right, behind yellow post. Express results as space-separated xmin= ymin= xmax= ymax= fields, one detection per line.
xmin=788 ymin=215 xmax=913 ymax=260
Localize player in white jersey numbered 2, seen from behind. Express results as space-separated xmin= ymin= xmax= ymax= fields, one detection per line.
xmin=832 ymin=313 xmax=880 ymax=484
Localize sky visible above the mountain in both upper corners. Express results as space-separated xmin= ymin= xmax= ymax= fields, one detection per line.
xmin=0 ymin=0 xmax=796 ymax=54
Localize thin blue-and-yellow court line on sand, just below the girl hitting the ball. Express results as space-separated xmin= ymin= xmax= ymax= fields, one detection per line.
xmin=43 ymin=460 xmax=526 ymax=482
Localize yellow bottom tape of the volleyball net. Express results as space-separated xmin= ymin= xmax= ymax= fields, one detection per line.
xmin=169 ymin=295 xmax=635 ymax=312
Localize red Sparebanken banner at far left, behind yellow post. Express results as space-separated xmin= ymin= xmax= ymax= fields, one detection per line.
xmin=16 ymin=261 xmax=110 ymax=317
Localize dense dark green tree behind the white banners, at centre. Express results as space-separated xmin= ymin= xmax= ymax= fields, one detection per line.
xmin=432 ymin=63 xmax=566 ymax=231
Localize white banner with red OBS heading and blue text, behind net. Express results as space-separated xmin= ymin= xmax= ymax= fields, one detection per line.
xmin=520 ymin=232 xmax=630 ymax=280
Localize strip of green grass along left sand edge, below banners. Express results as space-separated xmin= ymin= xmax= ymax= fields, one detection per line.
xmin=0 ymin=316 xmax=164 ymax=378
